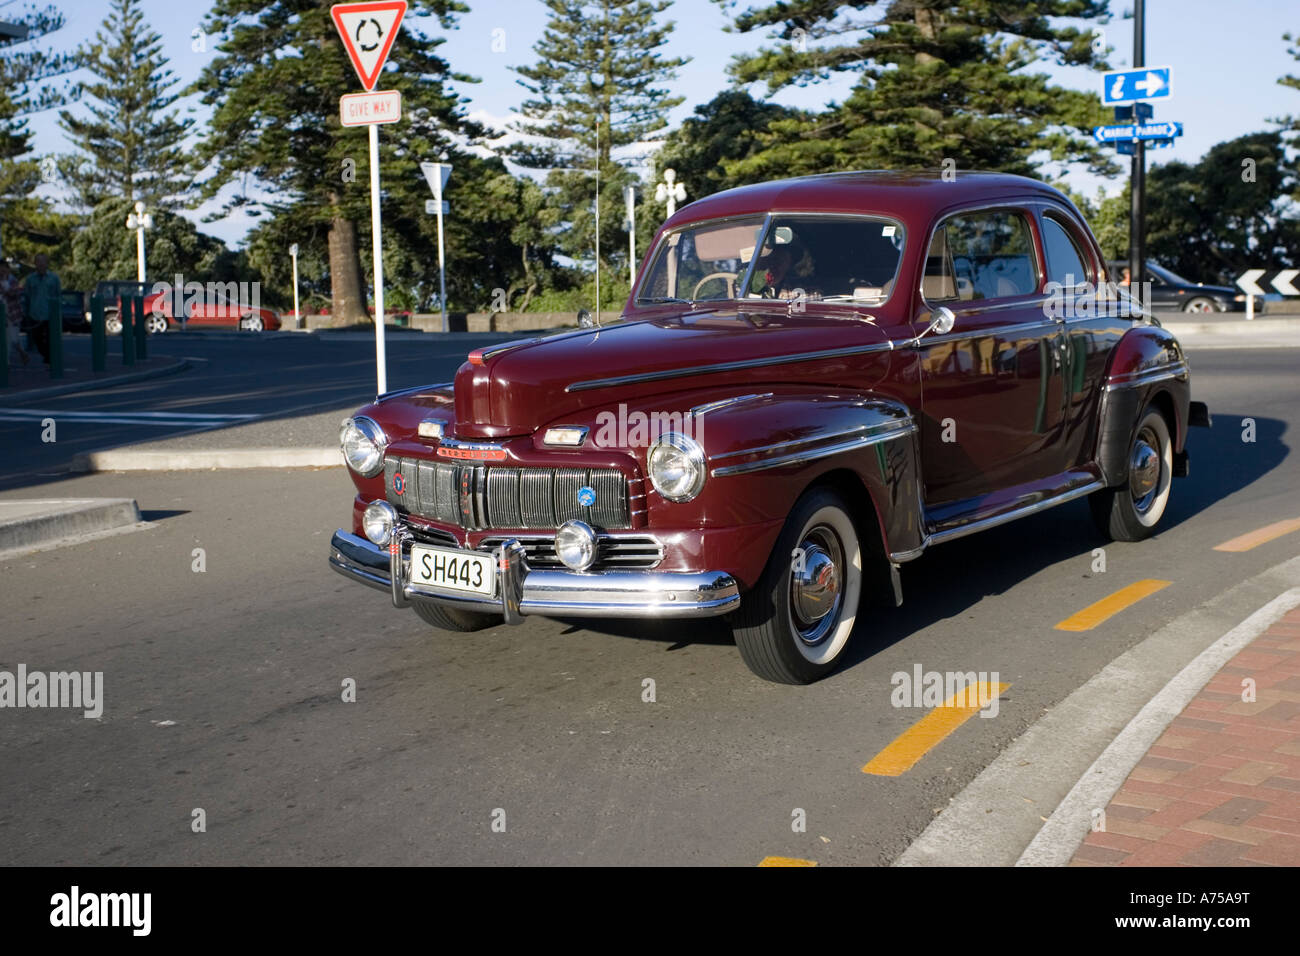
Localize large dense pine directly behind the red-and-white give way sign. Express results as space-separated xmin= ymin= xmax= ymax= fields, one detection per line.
xmin=195 ymin=0 xmax=478 ymax=324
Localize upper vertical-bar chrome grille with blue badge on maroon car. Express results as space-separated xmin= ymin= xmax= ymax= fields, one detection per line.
xmin=384 ymin=457 xmax=632 ymax=529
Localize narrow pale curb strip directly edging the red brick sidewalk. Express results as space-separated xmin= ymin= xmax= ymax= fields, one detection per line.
xmin=1015 ymin=588 xmax=1300 ymax=866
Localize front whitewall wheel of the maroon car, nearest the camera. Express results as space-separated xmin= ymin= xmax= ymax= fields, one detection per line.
xmin=733 ymin=488 xmax=862 ymax=684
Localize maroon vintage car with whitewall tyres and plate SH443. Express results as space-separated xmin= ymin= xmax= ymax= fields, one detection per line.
xmin=330 ymin=172 xmax=1209 ymax=683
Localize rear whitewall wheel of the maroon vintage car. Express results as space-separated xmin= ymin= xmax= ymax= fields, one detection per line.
xmin=1088 ymin=407 xmax=1174 ymax=541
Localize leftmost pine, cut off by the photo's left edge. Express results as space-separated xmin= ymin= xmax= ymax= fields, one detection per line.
xmin=0 ymin=5 xmax=74 ymax=261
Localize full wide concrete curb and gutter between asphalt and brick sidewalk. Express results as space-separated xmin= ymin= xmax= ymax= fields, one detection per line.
xmin=894 ymin=548 xmax=1300 ymax=866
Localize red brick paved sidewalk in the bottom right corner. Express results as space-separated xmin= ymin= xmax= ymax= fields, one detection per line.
xmin=1070 ymin=607 xmax=1300 ymax=866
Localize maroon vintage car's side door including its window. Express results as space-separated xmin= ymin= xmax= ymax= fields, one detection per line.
xmin=915 ymin=204 xmax=1063 ymax=515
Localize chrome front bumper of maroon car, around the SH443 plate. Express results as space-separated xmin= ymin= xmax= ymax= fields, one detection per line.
xmin=329 ymin=529 xmax=740 ymax=624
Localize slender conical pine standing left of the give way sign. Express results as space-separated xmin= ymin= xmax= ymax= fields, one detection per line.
xmin=59 ymin=0 xmax=194 ymax=211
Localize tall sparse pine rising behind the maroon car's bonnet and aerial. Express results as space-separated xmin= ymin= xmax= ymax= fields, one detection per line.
xmin=510 ymin=0 xmax=688 ymax=278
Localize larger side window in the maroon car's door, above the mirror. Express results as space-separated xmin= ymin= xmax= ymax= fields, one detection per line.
xmin=922 ymin=209 xmax=1039 ymax=302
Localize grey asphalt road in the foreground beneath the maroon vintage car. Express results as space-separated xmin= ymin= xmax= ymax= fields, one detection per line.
xmin=0 ymin=342 xmax=1300 ymax=865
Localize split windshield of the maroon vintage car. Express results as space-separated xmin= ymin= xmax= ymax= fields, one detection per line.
xmin=637 ymin=213 xmax=904 ymax=304
